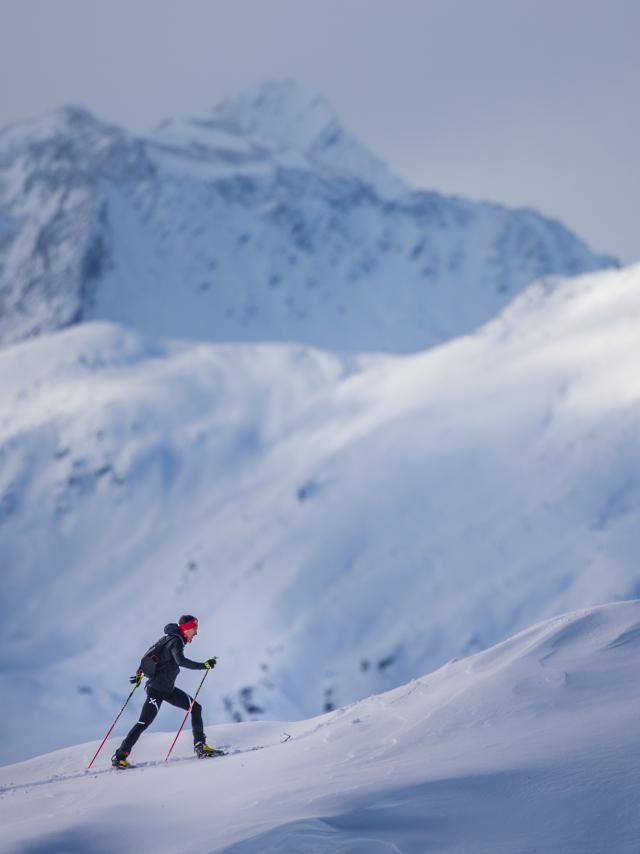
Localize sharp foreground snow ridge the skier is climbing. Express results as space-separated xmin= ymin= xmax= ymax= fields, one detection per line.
xmin=0 ymin=602 xmax=640 ymax=854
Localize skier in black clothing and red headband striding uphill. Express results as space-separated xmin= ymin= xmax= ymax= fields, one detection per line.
xmin=111 ymin=614 xmax=220 ymax=768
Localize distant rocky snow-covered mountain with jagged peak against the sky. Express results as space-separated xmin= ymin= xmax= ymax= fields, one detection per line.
xmin=0 ymin=81 xmax=616 ymax=352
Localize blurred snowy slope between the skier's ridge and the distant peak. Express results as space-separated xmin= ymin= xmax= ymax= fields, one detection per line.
xmin=0 ymin=267 xmax=640 ymax=762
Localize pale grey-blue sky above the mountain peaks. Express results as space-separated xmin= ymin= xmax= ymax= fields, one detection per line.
xmin=0 ymin=0 xmax=640 ymax=262
